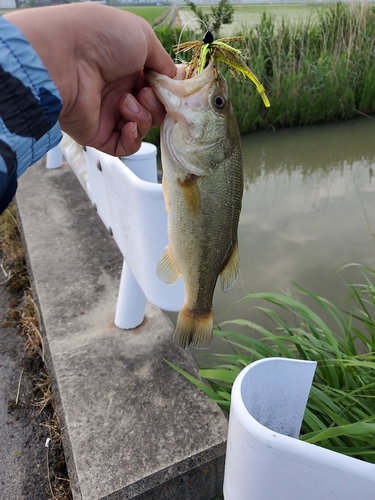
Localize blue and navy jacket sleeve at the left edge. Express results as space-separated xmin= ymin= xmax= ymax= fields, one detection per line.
xmin=0 ymin=16 xmax=62 ymax=213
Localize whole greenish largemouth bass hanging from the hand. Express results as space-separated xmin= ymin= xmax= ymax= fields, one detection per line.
xmin=147 ymin=63 xmax=243 ymax=348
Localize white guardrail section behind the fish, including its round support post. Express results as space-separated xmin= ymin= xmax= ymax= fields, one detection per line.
xmin=61 ymin=135 xmax=184 ymax=329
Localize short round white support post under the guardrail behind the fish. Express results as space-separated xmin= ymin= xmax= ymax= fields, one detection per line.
xmin=115 ymin=260 xmax=147 ymax=330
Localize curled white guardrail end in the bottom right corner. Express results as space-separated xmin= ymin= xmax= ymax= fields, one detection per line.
xmin=224 ymin=358 xmax=375 ymax=500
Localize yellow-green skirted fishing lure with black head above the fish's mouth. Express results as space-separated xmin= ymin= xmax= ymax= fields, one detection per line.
xmin=173 ymin=31 xmax=270 ymax=108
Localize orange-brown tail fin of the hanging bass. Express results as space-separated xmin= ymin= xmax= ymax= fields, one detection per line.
xmin=173 ymin=309 xmax=214 ymax=349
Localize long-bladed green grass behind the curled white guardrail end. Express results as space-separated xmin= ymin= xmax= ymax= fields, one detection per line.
xmin=170 ymin=266 xmax=375 ymax=463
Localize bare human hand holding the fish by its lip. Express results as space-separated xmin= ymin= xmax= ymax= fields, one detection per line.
xmin=5 ymin=3 xmax=176 ymax=156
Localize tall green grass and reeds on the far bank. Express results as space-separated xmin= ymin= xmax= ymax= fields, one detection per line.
xmin=157 ymin=3 xmax=375 ymax=132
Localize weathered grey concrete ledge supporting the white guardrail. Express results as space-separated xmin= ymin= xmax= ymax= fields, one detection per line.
xmin=17 ymin=160 xmax=227 ymax=500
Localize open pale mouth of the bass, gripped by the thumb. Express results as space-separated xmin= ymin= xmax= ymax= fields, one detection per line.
xmin=145 ymin=62 xmax=215 ymax=120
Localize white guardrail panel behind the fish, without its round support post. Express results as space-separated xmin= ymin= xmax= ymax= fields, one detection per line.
xmin=81 ymin=145 xmax=184 ymax=317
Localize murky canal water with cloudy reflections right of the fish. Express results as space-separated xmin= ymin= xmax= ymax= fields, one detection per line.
xmin=206 ymin=115 xmax=375 ymax=350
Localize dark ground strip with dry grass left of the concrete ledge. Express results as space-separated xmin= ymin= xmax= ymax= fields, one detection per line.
xmin=0 ymin=219 xmax=72 ymax=500
